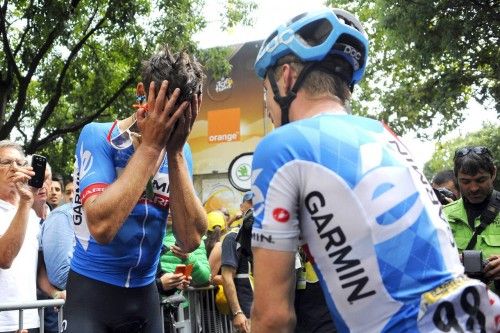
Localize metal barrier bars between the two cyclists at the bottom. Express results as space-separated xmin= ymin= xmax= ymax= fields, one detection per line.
xmin=162 ymin=286 xmax=235 ymax=333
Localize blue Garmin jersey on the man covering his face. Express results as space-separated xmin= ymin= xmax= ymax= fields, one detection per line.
xmin=71 ymin=122 xmax=192 ymax=288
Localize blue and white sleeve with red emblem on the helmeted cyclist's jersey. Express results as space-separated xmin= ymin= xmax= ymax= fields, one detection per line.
xmin=252 ymin=131 xmax=300 ymax=252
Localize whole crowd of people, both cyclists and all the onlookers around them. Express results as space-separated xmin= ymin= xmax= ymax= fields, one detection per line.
xmin=0 ymin=8 xmax=500 ymax=333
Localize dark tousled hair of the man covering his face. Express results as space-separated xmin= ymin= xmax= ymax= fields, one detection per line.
xmin=142 ymin=46 xmax=204 ymax=104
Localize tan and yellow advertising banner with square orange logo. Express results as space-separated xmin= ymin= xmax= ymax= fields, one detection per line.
xmin=188 ymin=41 xmax=272 ymax=175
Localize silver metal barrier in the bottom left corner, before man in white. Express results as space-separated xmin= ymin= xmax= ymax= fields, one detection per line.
xmin=0 ymin=299 xmax=65 ymax=333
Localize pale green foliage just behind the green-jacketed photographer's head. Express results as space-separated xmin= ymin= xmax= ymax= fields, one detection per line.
xmin=424 ymin=124 xmax=500 ymax=189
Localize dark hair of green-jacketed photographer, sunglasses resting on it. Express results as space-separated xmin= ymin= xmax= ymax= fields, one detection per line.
xmin=453 ymin=147 xmax=495 ymax=177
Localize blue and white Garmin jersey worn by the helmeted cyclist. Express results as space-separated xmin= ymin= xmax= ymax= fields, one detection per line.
xmin=252 ymin=114 xmax=463 ymax=332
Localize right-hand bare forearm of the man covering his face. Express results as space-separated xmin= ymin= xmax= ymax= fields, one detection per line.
xmin=167 ymin=152 xmax=207 ymax=252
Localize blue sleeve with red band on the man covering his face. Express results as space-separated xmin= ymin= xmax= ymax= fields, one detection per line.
xmin=76 ymin=123 xmax=116 ymax=204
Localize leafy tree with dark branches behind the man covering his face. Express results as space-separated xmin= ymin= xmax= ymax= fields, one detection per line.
xmin=0 ymin=0 xmax=255 ymax=173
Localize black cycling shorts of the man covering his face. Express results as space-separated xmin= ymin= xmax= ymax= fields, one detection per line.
xmin=63 ymin=270 xmax=162 ymax=333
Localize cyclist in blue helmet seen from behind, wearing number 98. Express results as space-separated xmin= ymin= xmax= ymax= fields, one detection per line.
xmin=252 ymin=9 xmax=500 ymax=333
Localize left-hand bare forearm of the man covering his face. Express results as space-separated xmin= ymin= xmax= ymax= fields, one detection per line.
xmin=84 ymin=145 xmax=160 ymax=243
